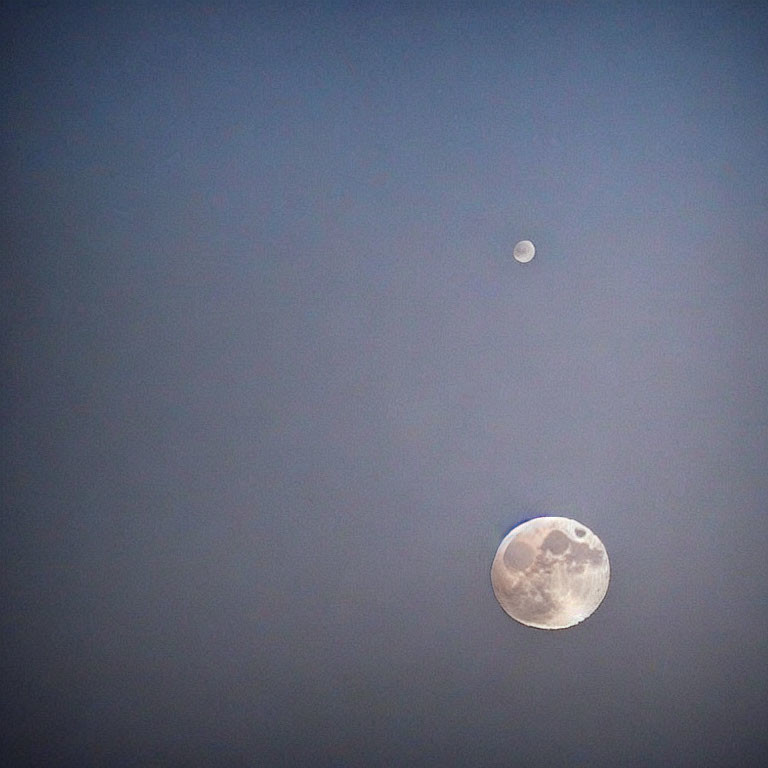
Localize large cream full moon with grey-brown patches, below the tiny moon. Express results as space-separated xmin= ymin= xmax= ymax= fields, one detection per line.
xmin=491 ymin=517 xmax=611 ymax=629
